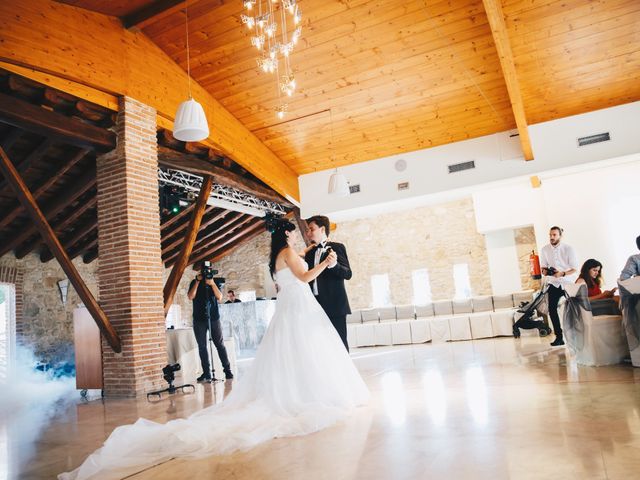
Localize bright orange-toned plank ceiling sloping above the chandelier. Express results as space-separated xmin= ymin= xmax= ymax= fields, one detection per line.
xmin=46 ymin=0 xmax=640 ymax=174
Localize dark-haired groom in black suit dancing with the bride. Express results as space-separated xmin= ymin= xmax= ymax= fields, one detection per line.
xmin=304 ymin=215 xmax=351 ymax=352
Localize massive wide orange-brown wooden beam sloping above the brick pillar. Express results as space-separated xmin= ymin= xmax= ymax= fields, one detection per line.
xmin=0 ymin=0 xmax=300 ymax=200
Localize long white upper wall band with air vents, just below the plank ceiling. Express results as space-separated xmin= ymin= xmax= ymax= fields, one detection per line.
xmin=299 ymin=102 xmax=640 ymax=221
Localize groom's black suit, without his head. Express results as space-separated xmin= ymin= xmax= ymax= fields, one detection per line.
xmin=304 ymin=242 xmax=351 ymax=351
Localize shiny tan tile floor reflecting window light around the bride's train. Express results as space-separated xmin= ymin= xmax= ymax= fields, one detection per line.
xmin=0 ymin=337 xmax=640 ymax=480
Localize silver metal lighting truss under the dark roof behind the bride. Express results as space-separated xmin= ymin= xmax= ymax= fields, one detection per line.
xmin=158 ymin=168 xmax=287 ymax=216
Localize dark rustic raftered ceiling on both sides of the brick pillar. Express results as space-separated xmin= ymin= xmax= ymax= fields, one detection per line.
xmin=0 ymin=69 xmax=280 ymax=267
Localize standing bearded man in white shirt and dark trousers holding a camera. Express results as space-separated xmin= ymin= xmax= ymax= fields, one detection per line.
xmin=540 ymin=226 xmax=578 ymax=347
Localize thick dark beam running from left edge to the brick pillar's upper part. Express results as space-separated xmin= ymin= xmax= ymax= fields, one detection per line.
xmin=0 ymin=93 xmax=116 ymax=152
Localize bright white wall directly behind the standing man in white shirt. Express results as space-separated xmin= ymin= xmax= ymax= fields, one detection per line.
xmin=473 ymin=158 xmax=640 ymax=287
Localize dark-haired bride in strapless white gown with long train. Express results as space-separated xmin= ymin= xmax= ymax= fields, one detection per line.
xmin=58 ymin=219 xmax=369 ymax=480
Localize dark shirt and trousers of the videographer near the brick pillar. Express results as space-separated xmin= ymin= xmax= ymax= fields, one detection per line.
xmin=189 ymin=280 xmax=231 ymax=376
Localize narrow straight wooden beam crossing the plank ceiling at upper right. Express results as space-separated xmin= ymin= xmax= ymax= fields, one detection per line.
xmin=482 ymin=0 xmax=533 ymax=160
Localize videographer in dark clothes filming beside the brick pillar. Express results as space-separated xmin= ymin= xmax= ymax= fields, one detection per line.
xmin=188 ymin=262 xmax=233 ymax=382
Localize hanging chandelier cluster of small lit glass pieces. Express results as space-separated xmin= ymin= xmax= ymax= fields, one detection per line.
xmin=240 ymin=0 xmax=302 ymax=118
